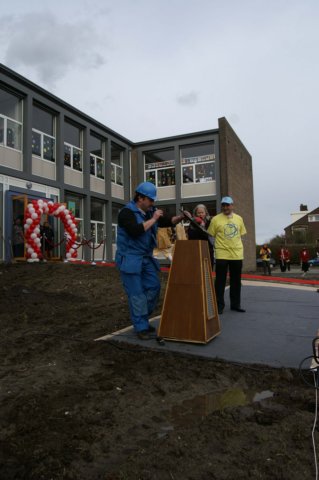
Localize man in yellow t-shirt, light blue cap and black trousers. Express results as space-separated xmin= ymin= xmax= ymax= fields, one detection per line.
xmin=208 ymin=196 xmax=247 ymax=314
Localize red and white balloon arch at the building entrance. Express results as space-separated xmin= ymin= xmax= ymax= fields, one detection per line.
xmin=24 ymin=199 xmax=78 ymax=262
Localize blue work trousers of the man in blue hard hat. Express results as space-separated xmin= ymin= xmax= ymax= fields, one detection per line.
xmin=120 ymin=257 xmax=161 ymax=332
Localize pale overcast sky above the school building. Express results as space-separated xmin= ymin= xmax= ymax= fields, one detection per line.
xmin=0 ymin=0 xmax=319 ymax=243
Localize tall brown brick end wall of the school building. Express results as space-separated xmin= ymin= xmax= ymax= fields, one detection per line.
xmin=218 ymin=117 xmax=256 ymax=272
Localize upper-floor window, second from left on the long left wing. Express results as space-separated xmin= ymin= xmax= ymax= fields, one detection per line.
xmin=32 ymin=105 xmax=55 ymax=162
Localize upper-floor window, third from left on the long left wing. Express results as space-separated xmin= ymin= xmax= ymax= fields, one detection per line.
xmin=64 ymin=121 xmax=83 ymax=172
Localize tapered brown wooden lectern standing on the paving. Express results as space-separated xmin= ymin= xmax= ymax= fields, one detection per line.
xmin=158 ymin=240 xmax=220 ymax=343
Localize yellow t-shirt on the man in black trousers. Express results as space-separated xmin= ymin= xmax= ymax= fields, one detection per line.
xmin=208 ymin=213 xmax=247 ymax=260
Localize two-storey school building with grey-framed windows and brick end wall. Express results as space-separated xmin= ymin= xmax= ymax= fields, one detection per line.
xmin=0 ymin=64 xmax=256 ymax=271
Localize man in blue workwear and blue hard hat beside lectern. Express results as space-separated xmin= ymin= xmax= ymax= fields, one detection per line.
xmin=115 ymin=182 xmax=184 ymax=340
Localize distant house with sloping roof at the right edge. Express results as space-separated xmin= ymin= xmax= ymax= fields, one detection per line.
xmin=285 ymin=205 xmax=319 ymax=246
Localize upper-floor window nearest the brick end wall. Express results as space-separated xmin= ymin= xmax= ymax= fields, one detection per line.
xmin=180 ymin=142 xmax=215 ymax=184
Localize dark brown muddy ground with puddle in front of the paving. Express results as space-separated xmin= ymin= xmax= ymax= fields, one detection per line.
xmin=0 ymin=264 xmax=319 ymax=480
